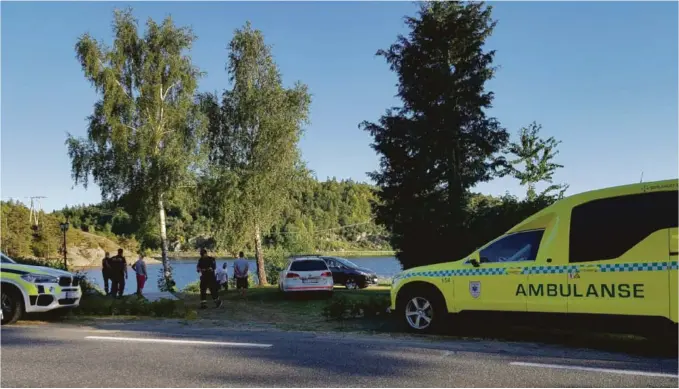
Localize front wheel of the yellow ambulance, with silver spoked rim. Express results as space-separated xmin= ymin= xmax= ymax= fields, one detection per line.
xmin=397 ymin=285 xmax=448 ymax=334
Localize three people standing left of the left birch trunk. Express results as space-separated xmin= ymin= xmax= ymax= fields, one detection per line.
xmin=101 ymin=249 xmax=149 ymax=297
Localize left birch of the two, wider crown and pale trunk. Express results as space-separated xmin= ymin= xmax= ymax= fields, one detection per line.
xmin=66 ymin=10 xmax=202 ymax=285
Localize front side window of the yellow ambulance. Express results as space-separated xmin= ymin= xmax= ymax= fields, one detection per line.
xmin=479 ymin=230 xmax=545 ymax=263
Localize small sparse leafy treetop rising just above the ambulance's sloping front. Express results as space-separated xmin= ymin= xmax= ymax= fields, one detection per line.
xmin=505 ymin=122 xmax=568 ymax=200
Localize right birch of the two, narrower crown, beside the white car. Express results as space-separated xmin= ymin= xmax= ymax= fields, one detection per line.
xmin=203 ymin=23 xmax=311 ymax=284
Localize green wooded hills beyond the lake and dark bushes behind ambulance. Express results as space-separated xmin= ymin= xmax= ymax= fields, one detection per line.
xmin=1 ymin=179 xmax=553 ymax=258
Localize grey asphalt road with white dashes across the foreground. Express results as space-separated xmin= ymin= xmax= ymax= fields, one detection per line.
xmin=0 ymin=322 xmax=678 ymax=388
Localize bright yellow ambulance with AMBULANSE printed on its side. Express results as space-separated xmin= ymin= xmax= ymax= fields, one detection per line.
xmin=390 ymin=180 xmax=679 ymax=332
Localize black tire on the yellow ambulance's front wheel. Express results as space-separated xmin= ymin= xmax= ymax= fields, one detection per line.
xmin=396 ymin=283 xmax=448 ymax=334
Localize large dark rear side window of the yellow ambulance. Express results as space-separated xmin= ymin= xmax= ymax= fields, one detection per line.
xmin=568 ymin=191 xmax=679 ymax=263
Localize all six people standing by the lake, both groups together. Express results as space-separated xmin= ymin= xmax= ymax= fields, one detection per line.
xmin=101 ymin=249 xmax=250 ymax=308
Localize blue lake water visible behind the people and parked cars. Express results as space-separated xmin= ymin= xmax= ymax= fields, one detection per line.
xmin=84 ymin=257 xmax=401 ymax=293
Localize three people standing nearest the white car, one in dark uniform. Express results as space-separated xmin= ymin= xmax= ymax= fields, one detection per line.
xmin=196 ymin=249 xmax=250 ymax=309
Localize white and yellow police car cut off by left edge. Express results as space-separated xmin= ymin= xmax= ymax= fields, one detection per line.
xmin=0 ymin=253 xmax=82 ymax=324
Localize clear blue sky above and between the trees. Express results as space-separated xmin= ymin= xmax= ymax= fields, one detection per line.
xmin=1 ymin=2 xmax=678 ymax=210
